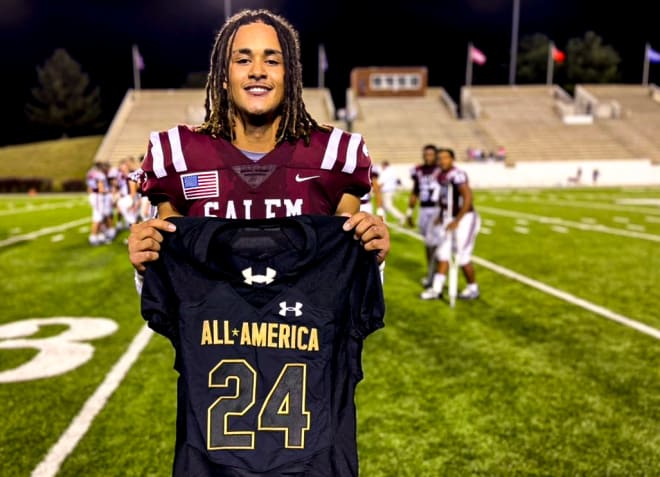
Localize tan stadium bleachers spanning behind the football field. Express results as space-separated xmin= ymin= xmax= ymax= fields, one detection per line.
xmin=95 ymin=85 xmax=660 ymax=178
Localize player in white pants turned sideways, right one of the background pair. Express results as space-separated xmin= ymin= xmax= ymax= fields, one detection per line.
xmin=420 ymin=149 xmax=481 ymax=300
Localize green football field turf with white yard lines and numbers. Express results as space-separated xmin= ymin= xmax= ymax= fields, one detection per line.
xmin=0 ymin=188 xmax=660 ymax=477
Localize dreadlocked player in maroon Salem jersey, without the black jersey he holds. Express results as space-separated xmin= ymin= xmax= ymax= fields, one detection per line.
xmin=128 ymin=10 xmax=390 ymax=274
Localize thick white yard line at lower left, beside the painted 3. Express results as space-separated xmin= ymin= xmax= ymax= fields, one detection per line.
xmin=31 ymin=324 xmax=153 ymax=477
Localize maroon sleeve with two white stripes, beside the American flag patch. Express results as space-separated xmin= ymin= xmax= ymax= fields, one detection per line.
xmin=140 ymin=126 xmax=188 ymax=214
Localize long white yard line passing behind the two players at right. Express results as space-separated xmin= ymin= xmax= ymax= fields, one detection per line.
xmin=389 ymin=224 xmax=660 ymax=340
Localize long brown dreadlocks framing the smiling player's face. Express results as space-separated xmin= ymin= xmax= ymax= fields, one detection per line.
xmin=199 ymin=9 xmax=327 ymax=144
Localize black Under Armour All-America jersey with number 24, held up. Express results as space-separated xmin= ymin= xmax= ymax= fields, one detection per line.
xmin=141 ymin=215 xmax=385 ymax=477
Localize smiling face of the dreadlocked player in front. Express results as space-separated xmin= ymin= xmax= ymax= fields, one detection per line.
xmin=227 ymin=22 xmax=285 ymax=122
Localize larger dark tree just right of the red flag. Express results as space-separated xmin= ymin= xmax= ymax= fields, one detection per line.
xmin=566 ymin=31 xmax=621 ymax=83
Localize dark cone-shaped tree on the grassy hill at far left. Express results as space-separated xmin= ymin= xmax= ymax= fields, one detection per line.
xmin=25 ymin=48 xmax=103 ymax=135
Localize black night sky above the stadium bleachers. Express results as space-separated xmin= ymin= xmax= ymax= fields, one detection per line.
xmin=0 ymin=0 xmax=660 ymax=145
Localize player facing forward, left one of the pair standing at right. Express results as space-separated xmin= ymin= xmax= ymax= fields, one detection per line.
xmin=406 ymin=144 xmax=440 ymax=288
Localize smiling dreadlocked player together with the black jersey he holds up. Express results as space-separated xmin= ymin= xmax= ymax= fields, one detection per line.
xmin=128 ymin=10 xmax=390 ymax=477
